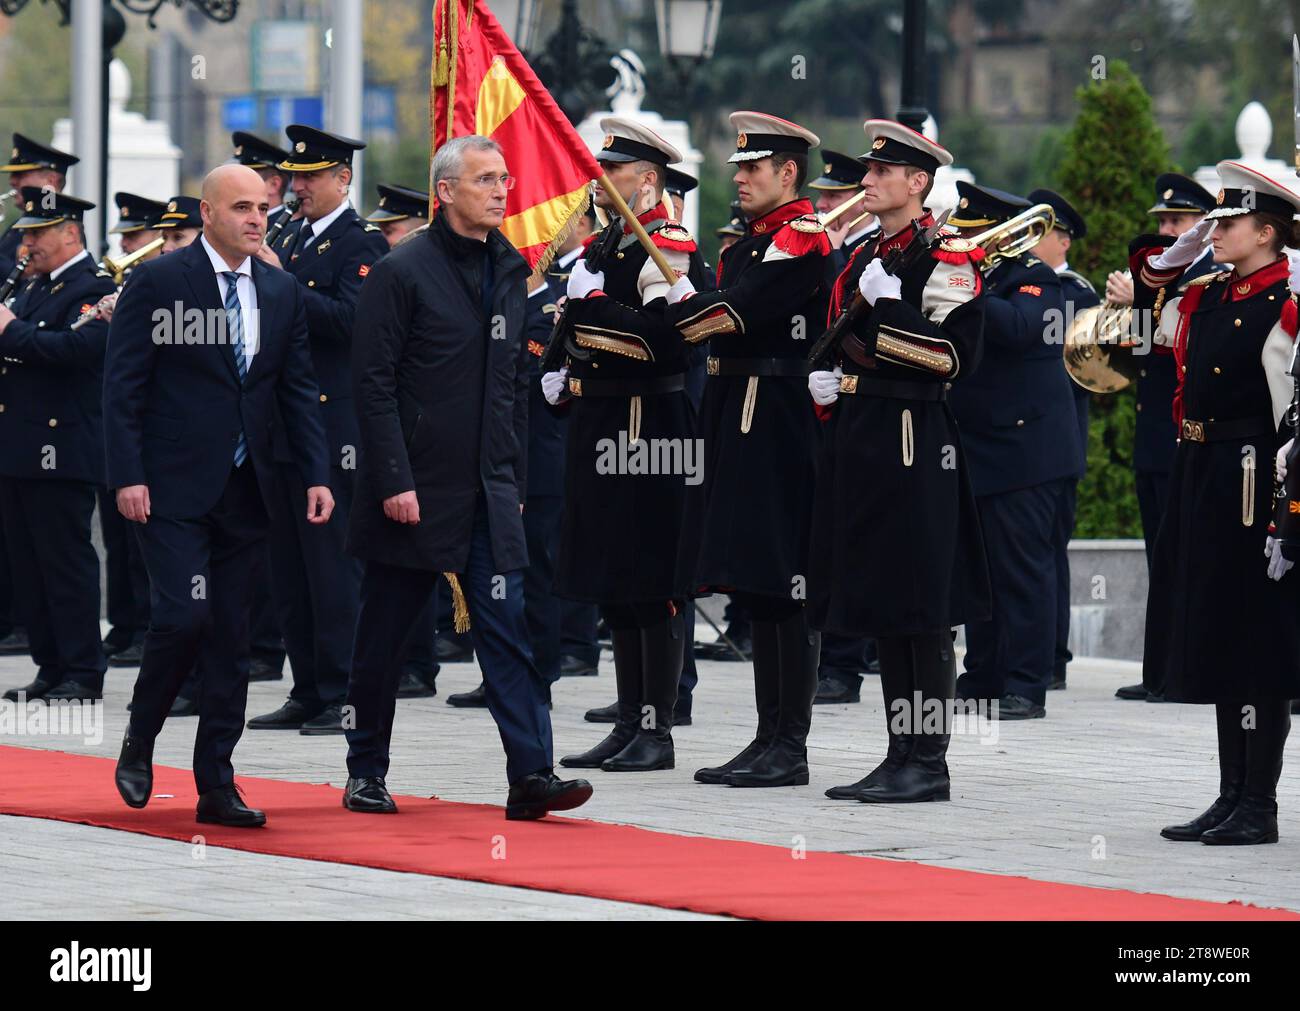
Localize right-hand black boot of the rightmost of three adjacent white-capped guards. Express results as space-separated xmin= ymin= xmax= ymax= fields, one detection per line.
xmin=858 ymin=629 xmax=957 ymax=804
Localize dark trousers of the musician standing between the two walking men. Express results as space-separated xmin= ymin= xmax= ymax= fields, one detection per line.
xmin=270 ymin=464 xmax=361 ymax=711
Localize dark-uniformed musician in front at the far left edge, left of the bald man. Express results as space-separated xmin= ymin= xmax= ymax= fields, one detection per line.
xmin=0 ymin=193 xmax=116 ymax=700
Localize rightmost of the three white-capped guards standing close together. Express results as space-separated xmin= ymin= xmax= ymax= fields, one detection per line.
xmin=809 ymin=120 xmax=989 ymax=803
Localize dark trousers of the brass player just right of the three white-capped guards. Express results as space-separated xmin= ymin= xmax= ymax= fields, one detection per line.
xmin=958 ymin=480 xmax=1065 ymax=706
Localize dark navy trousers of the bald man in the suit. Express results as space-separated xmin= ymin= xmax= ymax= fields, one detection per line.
xmin=131 ymin=463 xmax=267 ymax=794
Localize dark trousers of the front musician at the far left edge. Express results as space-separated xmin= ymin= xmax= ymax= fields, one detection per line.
xmin=0 ymin=477 xmax=108 ymax=691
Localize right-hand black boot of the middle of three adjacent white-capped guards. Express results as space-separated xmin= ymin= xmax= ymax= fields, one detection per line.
xmin=727 ymin=607 xmax=822 ymax=786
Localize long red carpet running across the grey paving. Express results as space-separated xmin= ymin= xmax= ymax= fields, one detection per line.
xmin=0 ymin=747 xmax=1300 ymax=920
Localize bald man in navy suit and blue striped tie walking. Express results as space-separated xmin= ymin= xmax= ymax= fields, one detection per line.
xmin=104 ymin=165 xmax=334 ymax=826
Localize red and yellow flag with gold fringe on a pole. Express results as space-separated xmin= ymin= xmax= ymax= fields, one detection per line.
xmin=430 ymin=0 xmax=601 ymax=273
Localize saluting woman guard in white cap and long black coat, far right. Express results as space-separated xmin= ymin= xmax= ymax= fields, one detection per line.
xmin=1130 ymin=161 xmax=1300 ymax=846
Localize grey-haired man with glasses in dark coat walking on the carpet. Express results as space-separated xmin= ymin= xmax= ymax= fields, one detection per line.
xmin=343 ymin=136 xmax=592 ymax=819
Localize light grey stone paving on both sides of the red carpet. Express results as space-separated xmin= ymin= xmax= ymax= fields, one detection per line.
xmin=0 ymin=651 xmax=1300 ymax=920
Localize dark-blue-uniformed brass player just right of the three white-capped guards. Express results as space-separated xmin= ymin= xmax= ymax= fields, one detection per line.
xmin=948 ymin=181 xmax=1083 ymax=720
